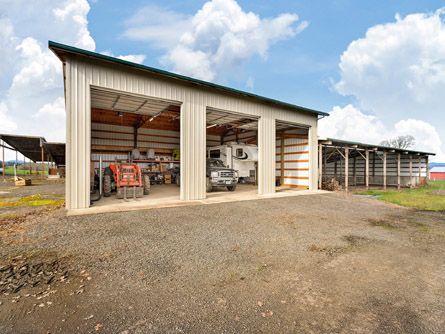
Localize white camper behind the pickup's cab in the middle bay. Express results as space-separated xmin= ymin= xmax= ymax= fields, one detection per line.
xmin=207 ymin=142 xmax=258 ymax=183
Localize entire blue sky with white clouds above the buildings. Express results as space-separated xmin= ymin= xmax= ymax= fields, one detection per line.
xmin=0 ymin=0 xmax=445 ymax=162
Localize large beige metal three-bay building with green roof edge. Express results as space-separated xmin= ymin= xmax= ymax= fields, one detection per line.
xmin=49 ymin=42 xmax=327 ymax=210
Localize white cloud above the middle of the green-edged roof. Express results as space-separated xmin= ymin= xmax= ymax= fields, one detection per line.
xmin=124 ymin=0 xmax=308 ymax=81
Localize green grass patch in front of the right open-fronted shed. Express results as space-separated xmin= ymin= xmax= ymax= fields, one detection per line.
xmin=355 ymin=181 xmax=445 ymax=211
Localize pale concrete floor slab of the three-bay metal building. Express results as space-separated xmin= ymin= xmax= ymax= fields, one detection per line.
xmin=72 ymin=184 xmax=325 ymax=216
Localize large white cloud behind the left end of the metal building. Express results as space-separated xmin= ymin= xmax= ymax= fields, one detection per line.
xmin=0 ymin=0 xmax=145 ymax=149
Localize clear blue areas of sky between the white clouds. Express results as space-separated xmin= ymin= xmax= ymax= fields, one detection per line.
xmin=89 ymin=0 xmax=445 ymax=111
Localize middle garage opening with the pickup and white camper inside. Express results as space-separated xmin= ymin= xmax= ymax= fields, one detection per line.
xmin=206 ymin=108 xmax=258 ymax=197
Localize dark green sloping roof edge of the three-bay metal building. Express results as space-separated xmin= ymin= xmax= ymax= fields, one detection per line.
xmin=48 ymin=41 xmax=329 ymax=117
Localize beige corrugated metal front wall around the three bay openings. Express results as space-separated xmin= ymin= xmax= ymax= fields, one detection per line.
xmin=66 ymin=56 xmax=318 ymax=209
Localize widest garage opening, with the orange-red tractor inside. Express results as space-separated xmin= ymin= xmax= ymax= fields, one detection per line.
xmin=90 ymin=88 xmax=180 ymax=206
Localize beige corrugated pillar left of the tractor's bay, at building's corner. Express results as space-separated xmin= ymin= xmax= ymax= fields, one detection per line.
xmin=65 ymin=60 xmax=91 ymax=209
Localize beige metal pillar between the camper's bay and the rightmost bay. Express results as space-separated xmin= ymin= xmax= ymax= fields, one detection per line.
xmin=258 ymin=113 xmax=276 ymax=195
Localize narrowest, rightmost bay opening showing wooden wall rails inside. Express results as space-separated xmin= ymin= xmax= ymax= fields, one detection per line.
xmin=275 ymin=121 xmax=309 ymax=191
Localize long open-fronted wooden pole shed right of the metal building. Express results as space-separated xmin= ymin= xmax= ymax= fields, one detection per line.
xmin=318 ymin=138 xmax=434 ymax=190
